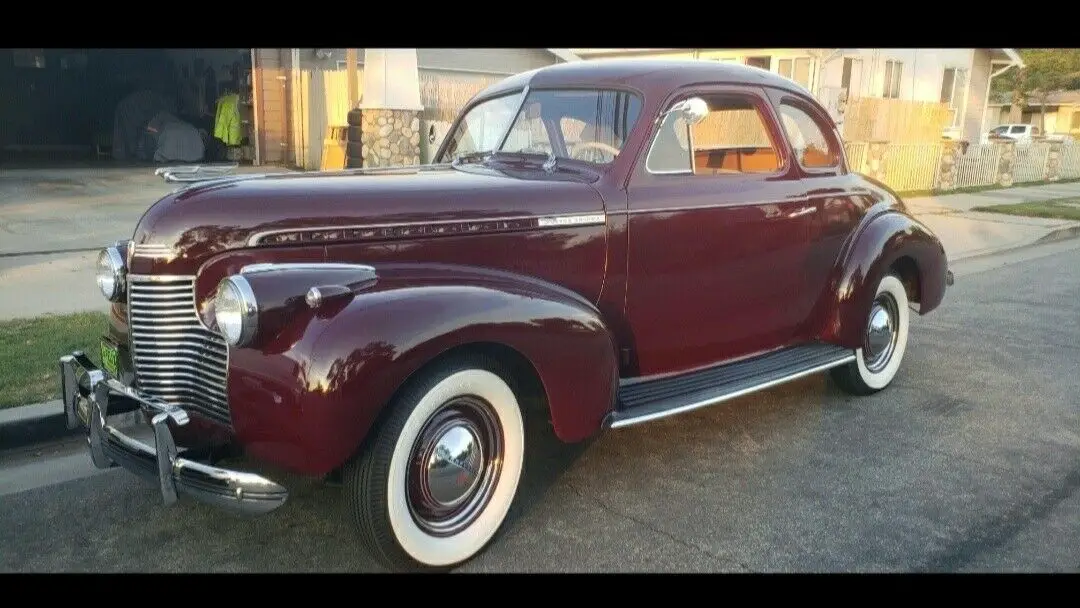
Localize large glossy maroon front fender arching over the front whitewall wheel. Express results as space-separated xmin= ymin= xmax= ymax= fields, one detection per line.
xmin=234 ymin=265 xmax=618 ymax=474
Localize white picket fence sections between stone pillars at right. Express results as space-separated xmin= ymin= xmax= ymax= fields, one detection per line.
xmin=845 ymin=141 xmax=1080 ymax=191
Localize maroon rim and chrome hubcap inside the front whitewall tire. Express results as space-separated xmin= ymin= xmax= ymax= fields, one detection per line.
xmin=407 ymin=397 xmax=502 ymax=536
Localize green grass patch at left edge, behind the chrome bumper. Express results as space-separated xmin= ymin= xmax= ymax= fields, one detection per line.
xmin=0 ymin=312 xmax=108 ymax=408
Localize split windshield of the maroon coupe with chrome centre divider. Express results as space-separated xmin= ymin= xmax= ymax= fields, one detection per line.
xmin=436 ymin=89 xmax=642 ymax=164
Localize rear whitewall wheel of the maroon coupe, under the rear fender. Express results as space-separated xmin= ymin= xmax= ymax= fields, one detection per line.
xmin=832 ymin=274 xmax=909 ymax=395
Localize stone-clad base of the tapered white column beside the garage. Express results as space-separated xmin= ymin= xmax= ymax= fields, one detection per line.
xmin=360 ymin=108 xmax=420 ymax=168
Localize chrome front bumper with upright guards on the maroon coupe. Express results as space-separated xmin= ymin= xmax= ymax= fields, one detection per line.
xmin=60 ymin=352 xmax=288 ymax=514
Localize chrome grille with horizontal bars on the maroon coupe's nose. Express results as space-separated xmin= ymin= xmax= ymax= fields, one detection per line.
xmin=127 ymin=276 xmax=231 ymax=424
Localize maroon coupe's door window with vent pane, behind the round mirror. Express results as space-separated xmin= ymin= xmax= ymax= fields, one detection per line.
xmin=645 ymin=95 xmax=780 ymax=175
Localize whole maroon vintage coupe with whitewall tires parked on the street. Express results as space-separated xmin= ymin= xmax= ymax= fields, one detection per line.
xmin=60 ymin=60 xmax=953 ymax=569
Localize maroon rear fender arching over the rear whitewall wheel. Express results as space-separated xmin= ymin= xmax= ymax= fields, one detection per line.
xmin=821 ymin=208 xmax=948 ymax=349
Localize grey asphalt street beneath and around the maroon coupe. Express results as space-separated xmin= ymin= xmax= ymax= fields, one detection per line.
xmin=0 ymin=241 xmax=1080 ymax=572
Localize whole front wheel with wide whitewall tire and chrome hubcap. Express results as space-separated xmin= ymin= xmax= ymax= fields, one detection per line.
xmin=345 ymin=357 xmax=525 ymax=570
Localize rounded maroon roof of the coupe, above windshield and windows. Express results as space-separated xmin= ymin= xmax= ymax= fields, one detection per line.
xmin=476 ymin=58 xmax=812 ymax=98
